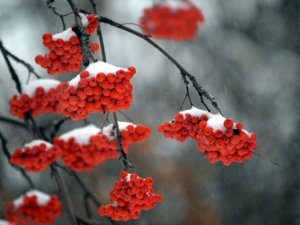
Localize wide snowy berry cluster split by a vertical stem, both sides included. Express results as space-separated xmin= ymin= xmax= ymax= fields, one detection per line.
xmin=54 ymin=122 xmax=150 ymax=171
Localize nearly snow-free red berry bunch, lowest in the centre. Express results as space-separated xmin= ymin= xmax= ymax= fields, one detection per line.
xmin=98 ymin=171 xmax=163 ymax=221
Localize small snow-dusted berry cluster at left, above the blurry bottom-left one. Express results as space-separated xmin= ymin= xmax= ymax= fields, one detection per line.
xmin=10 ymin=140 xmax=62 ymax=172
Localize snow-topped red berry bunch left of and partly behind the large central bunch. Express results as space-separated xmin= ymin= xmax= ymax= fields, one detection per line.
xmin=9 ymin=79 xmax=60 ymax=119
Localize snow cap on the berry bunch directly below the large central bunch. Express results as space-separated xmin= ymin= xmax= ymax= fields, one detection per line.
xmin=59 ymin=125 xmax=101 ymax=145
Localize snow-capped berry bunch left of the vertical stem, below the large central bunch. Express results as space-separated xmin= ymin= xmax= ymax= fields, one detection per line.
xmin=54 ymin=125 xmax=117 ymax=171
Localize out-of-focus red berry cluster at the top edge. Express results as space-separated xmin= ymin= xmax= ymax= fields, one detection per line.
xmin=140 ymin=1 xmax=204 ymax=41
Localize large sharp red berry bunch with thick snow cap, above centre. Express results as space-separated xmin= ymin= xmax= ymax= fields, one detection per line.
xmin=58 ymin=61 xmax=136 ymax=120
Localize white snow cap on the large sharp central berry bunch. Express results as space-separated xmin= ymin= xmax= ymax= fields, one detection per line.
xmin=68 ymin=61 xmax=127 ymax=87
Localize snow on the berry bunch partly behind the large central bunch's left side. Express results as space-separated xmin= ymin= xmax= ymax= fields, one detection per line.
xmin=22 ymin=79 xmax=60 ymax=96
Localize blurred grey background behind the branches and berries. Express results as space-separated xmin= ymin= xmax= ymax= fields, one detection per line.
xmin=0 ymin=0 xmax=300 ymax=225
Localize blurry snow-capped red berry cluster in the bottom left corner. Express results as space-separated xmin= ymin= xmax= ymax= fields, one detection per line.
xmin=4 ymin=190 xmax=61 ymax=225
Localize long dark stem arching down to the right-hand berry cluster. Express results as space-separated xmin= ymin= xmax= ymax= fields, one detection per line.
xmin=99 ymin=16 xmax=223 ymax=115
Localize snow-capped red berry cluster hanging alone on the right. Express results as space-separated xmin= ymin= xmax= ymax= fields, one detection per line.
xmin=158 ymin=107 xmax=256 ymax=166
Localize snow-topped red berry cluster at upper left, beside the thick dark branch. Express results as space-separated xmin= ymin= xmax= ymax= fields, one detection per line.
xmin=35 ymin=14 xmax=100 ymax=75
